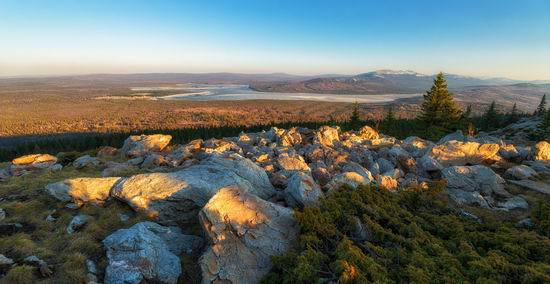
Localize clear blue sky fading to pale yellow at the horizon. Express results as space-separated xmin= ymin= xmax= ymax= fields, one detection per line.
xmin=0 ymin=0 xmax=550 ymax=80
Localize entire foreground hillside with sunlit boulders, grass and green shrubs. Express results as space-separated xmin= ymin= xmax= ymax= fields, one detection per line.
xmin=0 ymin=119 xmax=550 ymax=284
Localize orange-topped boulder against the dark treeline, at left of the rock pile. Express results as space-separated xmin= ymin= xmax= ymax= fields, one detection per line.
xmin=122 ymin=134 xmax=172 ymax=157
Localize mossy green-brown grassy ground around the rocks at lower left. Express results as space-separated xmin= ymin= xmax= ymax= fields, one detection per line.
xmin=0 ymin=161 xmax=149 ymax=284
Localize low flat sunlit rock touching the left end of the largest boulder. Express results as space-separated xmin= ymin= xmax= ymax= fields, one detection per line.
xmin=45 ymin=177 xmax=121 ymax=205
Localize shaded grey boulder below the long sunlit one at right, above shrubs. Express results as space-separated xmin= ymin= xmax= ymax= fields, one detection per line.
xmin=442 ymin=165 xmax=510 ymax=207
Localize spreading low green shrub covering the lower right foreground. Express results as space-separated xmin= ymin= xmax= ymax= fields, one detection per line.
xmin=263 ymin=183 xmax=550 ymax=283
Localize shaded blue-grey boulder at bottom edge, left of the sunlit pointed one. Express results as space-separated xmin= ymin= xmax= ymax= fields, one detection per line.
xmin=103 ymin=222 xmax=200 ymax=284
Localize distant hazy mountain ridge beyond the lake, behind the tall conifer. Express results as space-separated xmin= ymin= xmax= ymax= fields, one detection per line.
xmin=251 ymin=70 xmax=550 ymax=111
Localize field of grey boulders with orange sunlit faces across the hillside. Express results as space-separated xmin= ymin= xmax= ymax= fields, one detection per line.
xmin=4 ymin=118 xmax=550 ymax=283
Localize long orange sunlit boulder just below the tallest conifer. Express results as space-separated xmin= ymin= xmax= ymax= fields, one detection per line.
xmin=427 ymin=141 xmax=500 ymax=167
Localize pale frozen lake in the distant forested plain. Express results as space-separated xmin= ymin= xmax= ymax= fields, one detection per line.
xmin=132 ymin=84 xmax=422 ymax=103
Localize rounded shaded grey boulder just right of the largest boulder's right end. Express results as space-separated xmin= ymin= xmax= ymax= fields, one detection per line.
xmin=286 ymin=172 xmax=323 ymax=206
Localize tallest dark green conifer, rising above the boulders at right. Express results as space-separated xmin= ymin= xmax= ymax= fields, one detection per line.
xmin=420 ymin=73 xmax=461 ymax=130
